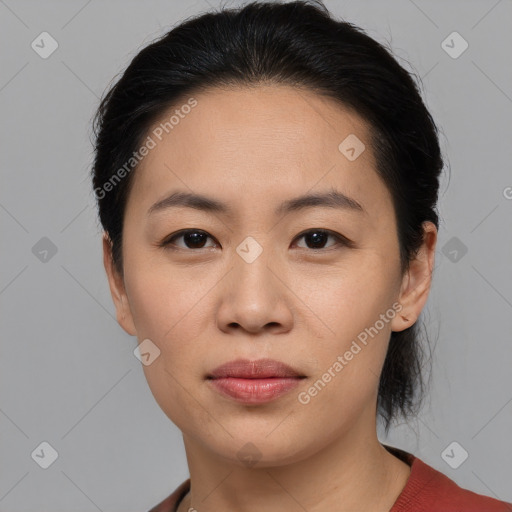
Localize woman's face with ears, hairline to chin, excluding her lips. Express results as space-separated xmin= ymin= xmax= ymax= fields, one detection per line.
xmin=104 ymin=86 xmax=435 ymax=466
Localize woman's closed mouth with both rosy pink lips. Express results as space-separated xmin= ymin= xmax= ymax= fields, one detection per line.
xmin=206 ymin=359 xmax=306 ymax=404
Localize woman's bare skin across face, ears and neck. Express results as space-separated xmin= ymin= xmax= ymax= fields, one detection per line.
xmin=103 ymin=85 xmax=437 ymax=512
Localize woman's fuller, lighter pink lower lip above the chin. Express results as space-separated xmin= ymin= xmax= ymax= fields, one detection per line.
xmin=209 ymin=377 xmax=302 ymax=404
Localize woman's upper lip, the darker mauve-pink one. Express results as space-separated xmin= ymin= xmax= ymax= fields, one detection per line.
xmin=208 ymin=359 xmax=305 ymax=379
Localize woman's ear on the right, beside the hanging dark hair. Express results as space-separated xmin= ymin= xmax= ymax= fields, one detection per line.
xmin=391 ymin=221 xmax=437 ymax=331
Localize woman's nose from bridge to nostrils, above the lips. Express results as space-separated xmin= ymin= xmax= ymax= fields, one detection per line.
xmin=217 ymin=244 xmax=293 ymax=334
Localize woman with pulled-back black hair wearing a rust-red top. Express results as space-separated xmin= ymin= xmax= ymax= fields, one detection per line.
xmin=93 ymin=2 xmax=510 ymax=512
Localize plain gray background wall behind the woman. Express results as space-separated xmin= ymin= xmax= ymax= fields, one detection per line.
xmin=0 ymin=0 xmax=512 ymax=512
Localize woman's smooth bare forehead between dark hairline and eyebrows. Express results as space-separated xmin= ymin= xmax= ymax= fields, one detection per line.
xmin=127 ymin=85 xmax=385 ymax=218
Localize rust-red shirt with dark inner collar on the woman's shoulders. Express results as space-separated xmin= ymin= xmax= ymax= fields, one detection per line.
xmin=148 ymin=445 xmax=512 ymax=512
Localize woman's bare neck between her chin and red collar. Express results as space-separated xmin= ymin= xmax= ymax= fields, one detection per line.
xmin=178 ymin=412 xmax=410 ymax=512
